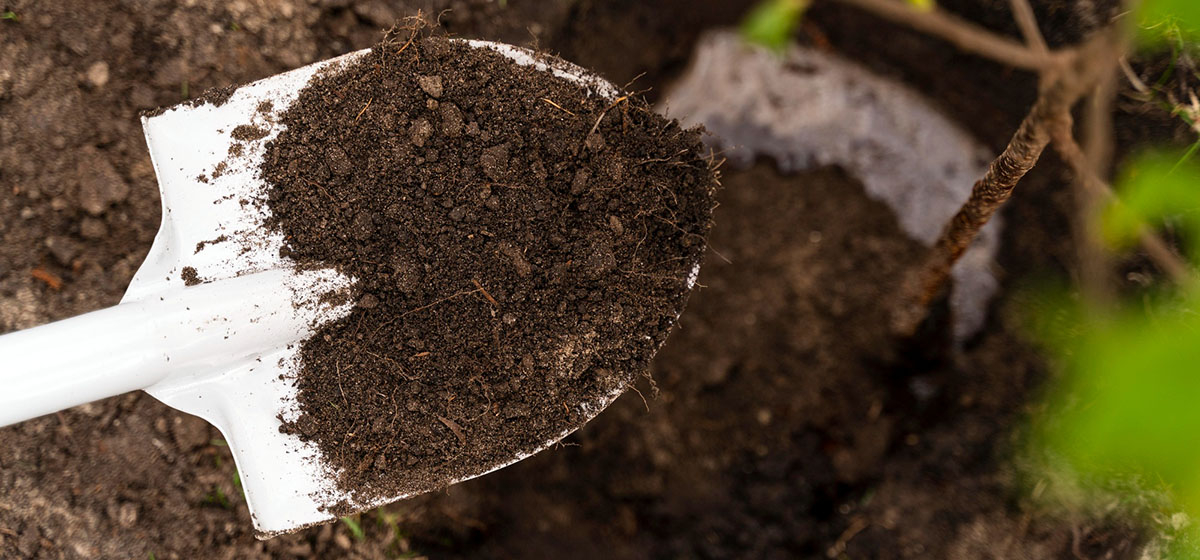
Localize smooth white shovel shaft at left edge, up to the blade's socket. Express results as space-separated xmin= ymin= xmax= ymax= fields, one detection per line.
xmin=0 ymin=301 xmax=167 ymax=426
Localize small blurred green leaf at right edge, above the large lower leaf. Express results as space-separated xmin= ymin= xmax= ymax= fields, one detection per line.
xmin=1100 ymin=151 xmax=1200 ymax=261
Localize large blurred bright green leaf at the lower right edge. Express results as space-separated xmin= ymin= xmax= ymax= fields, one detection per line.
xmin=1046 ymin=312 xmax=1200 ymax=486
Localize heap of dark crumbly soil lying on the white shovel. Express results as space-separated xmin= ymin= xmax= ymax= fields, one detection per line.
xmin=262 ymin=37 xmax=716 ymax=510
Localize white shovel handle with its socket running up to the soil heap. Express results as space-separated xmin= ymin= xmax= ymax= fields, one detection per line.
xmin=0 ymin=269 xmax=350 ymax=426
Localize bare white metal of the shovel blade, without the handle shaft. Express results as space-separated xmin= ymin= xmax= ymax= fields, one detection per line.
xmin=127 ymin=41 xmax=618 ymax=536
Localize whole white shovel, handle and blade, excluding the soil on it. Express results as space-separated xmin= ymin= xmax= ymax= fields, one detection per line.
xmin=0 ymin=41 xmax=633 ymax=537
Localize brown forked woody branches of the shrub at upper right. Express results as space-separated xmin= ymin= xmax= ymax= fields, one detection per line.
xmin=839 ymin=0 xmax=1192 ymax=337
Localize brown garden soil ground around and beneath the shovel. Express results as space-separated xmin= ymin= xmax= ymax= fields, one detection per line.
xmin=0 ymin=0 xmax=1161 ymax=559
